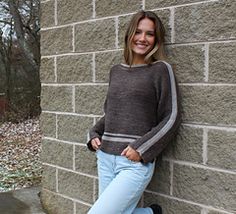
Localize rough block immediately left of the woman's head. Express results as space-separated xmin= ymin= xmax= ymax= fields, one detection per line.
xmin=75 ymin=19 xmax=116 ymax=52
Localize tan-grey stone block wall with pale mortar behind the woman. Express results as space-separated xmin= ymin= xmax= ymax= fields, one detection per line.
xmin=41 ymin=0 xmax=236 ymax=214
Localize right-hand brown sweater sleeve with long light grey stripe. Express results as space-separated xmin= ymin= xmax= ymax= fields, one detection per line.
xmin=130 ymin=62 xmax=180 ymax=163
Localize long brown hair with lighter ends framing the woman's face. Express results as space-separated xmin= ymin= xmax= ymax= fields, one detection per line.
xmin=124 ymin=10 xmax=166 ymax=65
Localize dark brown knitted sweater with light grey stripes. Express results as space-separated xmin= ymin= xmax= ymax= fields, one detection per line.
xmin=87 ymin=61 xmax=180 ymax=163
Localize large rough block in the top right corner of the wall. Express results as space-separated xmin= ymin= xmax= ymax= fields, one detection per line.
xmin=175 ymin=0 xmax=236 ymax=43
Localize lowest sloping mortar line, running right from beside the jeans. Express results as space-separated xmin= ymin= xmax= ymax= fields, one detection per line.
xmin=145 ymin=190 xmax=233 ymax=214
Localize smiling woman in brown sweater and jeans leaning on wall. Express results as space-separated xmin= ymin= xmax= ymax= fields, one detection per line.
xmin=88 ymin=11 xmax=180 ymax=214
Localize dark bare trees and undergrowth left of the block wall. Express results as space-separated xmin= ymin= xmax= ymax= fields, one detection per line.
xmin=0 ymin=0 xmax=41 ymax=120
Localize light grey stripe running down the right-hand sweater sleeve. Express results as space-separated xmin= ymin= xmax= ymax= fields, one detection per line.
xmin=137 ymin=61 xmax=178 ymax=154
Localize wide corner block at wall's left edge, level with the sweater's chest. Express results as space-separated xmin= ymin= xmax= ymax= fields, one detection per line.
xmin=41 ymin=86 xmax=72 ymax=112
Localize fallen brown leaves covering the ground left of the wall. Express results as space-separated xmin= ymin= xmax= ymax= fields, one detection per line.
xmin=0 ymin=118 xmax=42 ymax=192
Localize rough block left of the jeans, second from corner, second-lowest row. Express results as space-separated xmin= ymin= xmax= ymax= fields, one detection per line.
xmin=58 ymin=170 xmax=93 ymax=203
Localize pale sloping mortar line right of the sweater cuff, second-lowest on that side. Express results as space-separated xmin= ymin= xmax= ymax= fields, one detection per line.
xmin=163 ymin=158 xmax=236 ymax=175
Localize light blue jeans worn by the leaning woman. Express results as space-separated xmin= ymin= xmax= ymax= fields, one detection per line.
xmin=88 ymin=150 xmax=155 ymax=214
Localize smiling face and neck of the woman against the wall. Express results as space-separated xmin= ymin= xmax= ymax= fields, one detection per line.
xmin=131 ymin=18 xmax=155 ymax=64
